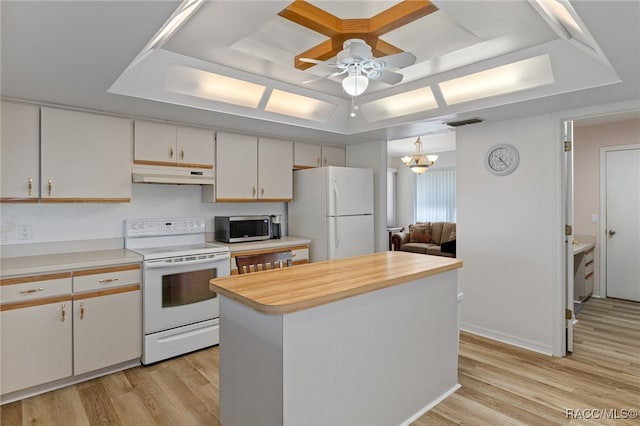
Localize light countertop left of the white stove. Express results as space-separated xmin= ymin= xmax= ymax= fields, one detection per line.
xmin=0 ymin=249 xmax=142 ymax=278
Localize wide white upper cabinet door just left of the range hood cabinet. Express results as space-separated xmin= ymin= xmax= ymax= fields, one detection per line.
xmin=40 ymin=108 xmax=132 ymax=202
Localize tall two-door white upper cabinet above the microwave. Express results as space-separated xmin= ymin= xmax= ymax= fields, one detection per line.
xmin=215 ymin=132 xmax=293 ymax=202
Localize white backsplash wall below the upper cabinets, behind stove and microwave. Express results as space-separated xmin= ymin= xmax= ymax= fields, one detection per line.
xmin=0 ymin=184 xmax=286 ymax=245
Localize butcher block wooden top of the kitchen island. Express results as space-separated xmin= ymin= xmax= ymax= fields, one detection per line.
xmin=210 ymin=251 xmax=462 ymax=315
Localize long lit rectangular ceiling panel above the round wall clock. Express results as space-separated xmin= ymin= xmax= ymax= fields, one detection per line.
xmin=439 ymin=55 xmax=555 ymax=105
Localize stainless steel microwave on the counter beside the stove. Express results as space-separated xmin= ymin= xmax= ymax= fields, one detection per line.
xmin=214 ymin=215 xmax=271 ymax=243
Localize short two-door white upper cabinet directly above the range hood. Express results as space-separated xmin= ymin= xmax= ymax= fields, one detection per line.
xmin=134 ymin=120 xmax=214 ymax=169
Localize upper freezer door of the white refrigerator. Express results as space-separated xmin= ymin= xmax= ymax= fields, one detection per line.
xmin=327 ymin=167 xmax=373 ymax=216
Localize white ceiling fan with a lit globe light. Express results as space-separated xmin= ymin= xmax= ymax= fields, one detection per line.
xmin=299 ymin=38 xmax=416 ymax=96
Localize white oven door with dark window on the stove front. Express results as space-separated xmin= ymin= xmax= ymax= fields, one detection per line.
xmin=142 ymin=253 xmax=229 ymax=334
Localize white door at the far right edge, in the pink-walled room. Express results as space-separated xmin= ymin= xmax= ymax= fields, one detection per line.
xmin=604 ymin=148 xmax=640 ymax=302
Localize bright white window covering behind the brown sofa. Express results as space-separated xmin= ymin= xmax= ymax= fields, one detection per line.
xmin=416 ymin=169 xmax=456 ymax=222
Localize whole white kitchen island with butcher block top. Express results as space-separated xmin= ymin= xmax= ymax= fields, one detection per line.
xmin=211 ymin=252 xmax=462 ymax=425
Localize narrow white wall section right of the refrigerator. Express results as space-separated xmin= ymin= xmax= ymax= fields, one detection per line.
xmin=347 ymin=141 xmax=389 ymax=251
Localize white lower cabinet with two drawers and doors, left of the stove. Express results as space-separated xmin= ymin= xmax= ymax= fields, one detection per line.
xmin=0 ymin=263 xmax=142 ymax=402
